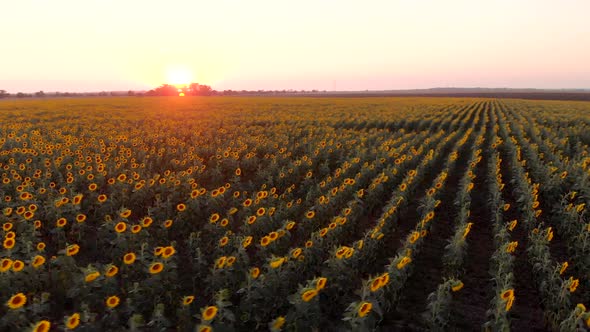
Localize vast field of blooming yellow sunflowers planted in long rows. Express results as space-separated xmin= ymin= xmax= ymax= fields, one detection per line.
xmin=0 ymin=97 xmax=590 ymax=332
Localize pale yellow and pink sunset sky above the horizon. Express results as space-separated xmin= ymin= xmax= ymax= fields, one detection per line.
xmin=0 ymin=0 xmax=590 ymax=93
